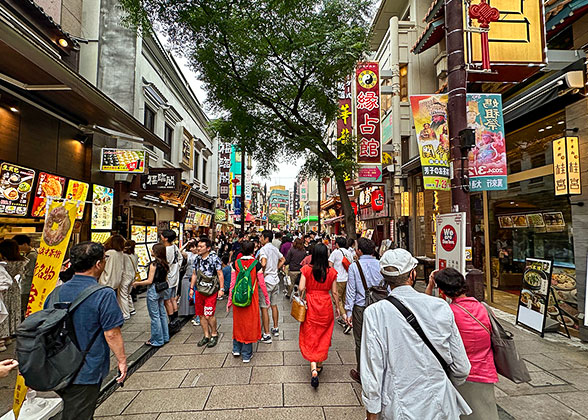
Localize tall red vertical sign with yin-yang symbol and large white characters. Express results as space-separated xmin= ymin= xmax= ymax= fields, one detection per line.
xmin=355 ymin=62 xmax=382 ymax=164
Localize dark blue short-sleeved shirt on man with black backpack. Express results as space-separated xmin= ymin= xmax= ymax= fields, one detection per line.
xmin=45 ymin=274 xmax=123 ymax=385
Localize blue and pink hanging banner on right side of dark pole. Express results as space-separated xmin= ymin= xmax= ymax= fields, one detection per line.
xmin=466 ymin=94 xmax=507 ymax=191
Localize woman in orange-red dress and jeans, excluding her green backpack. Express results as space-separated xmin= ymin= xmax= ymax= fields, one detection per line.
xmin=227 ymin=241 xmax=269 ymax=363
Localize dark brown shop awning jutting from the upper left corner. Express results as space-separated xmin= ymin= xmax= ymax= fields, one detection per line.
xmin=0 ymin=2 xmax=170 ymax=153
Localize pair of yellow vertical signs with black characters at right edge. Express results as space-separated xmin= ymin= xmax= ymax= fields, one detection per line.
xmin=553 ymin=137 xmax=582 ymax=195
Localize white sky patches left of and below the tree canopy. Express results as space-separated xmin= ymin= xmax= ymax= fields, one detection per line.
xmin=174 ymin=54 xmax=304 ymax=190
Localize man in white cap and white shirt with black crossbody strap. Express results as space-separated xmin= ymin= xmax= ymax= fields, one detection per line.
xmin=360 ymin=249 xmax=472 ymax=420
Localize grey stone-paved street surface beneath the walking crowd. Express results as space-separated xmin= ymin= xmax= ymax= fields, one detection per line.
xmin=89 ymin=292 xmax=588 ymax=420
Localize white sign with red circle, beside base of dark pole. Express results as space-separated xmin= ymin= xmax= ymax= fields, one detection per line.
xmin=436 ymin=212 xmax=466 ymax=275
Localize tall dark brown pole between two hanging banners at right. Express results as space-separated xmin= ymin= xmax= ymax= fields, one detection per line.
xmin=445 ymin=0 xmax=472 ymax=246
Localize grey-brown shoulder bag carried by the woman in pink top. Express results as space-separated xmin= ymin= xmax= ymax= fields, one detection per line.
xmin=454 ymin=302 xmax=531 ymax=384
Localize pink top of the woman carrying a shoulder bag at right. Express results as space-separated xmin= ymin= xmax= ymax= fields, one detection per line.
xmin=449 ymin=297 xmax=498 ymax=383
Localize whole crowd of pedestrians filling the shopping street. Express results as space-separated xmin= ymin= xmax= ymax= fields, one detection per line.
xmin=0 ymin=226 xmax=512 ymax=420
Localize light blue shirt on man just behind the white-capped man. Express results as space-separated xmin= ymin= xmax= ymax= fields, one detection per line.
xmin=345 ymin=255 xmax=384 ymax=316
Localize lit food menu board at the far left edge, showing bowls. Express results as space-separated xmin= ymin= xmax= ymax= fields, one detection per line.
xmin=0 ymin=162 xmax=35 ymax=216
